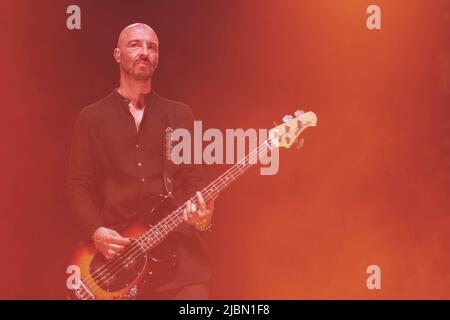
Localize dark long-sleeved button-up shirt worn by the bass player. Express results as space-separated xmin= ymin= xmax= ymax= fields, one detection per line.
xmin=66 ymin=90 xmax=209 ymax=289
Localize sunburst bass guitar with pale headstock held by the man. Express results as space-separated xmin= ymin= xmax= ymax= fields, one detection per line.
xmin=70 ymin=111 xmax=317 ymax=300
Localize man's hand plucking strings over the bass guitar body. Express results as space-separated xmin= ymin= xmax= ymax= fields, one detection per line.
xmin=92 ymin=227 xmax=131 ymax=260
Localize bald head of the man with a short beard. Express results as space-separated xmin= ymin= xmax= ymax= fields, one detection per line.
xmin=114 ymin=23 xmax=159 ymax=81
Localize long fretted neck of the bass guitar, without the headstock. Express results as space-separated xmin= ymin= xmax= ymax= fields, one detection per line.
xmin=139 ymin=139 xmax=273 ymax=251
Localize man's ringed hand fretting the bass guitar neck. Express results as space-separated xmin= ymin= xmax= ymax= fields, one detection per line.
xmin=183 ymin=191 xmax=217 ymax=231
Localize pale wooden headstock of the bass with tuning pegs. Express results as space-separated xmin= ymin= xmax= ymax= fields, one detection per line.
xmin=269 ymin=110 xmax=317 ymax=149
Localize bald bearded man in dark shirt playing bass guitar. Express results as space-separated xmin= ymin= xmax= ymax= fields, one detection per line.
xmin=67 ymin=23 xmax=214 ymax=299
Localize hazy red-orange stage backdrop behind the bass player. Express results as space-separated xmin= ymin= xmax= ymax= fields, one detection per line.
xmin=0 ymin=0 xmax=450 ymax=299
